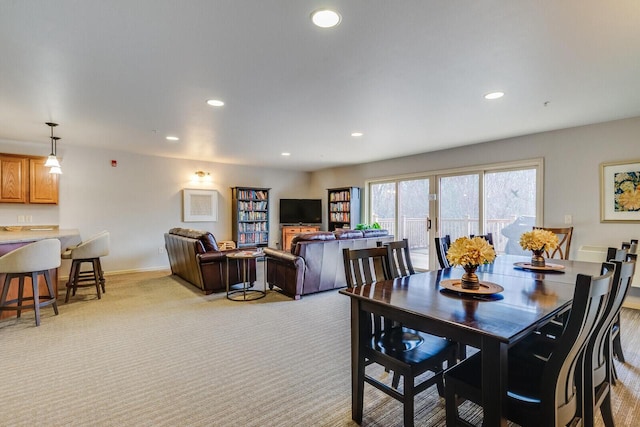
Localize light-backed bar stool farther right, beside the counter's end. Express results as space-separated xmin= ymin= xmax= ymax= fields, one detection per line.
xmin=62 ymin=231 xmax=109 ymax=303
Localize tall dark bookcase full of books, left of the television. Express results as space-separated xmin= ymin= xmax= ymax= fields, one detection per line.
xmin=231 ymin=187 xmax=270 ymax=248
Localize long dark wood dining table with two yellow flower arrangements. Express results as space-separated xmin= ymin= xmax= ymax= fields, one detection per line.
xmin=340 ymin=255 xmax=601 ymax=426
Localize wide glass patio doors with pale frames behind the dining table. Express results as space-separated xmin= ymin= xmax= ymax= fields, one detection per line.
xmin=366 ymin=159 xmax=543 ymax=269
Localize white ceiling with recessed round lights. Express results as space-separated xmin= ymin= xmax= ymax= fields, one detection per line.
xmin=0 ymin=0 xmax=640 ymax=171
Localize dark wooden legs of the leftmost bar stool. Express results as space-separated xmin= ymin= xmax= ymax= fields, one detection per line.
xmin=0 ymin=270 xmax=58 ymax=326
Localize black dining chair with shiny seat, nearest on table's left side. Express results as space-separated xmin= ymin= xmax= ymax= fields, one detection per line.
xmin=343 ymin=247 xmax=457 ymax=427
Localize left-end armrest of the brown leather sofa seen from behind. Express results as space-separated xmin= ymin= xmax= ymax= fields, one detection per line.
xmin=264 ymin=248 xmax=306 ymax=299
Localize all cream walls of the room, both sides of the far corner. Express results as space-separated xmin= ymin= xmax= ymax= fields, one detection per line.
xmin=0 ymin=117 xmax=640 ymax=274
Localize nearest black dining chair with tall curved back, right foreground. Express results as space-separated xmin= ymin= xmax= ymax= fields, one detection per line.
xmin=444 ymin=271 xmax=613 ymax=427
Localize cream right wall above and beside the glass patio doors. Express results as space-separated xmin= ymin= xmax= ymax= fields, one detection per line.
xmin=311 ymin=117 xmax=640 ymax=257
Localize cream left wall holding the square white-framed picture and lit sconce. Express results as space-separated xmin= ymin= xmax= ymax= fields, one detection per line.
xmin=0 ymin=141 xmax=312 ymax=276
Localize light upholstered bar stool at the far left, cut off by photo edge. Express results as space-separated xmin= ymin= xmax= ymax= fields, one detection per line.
xmin=0 ymin=239 xmax=60 ymax=326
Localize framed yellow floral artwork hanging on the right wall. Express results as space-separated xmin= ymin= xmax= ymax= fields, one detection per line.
xmin=600 ymin=160 xmax=640 ymax=222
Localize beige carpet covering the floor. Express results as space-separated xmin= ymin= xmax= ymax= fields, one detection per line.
xmin=0 ymin=272 xmax=640 ymax=427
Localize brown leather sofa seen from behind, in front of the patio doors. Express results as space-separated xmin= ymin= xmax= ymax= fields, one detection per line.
xmin=264 ymin=230 xmax=393 ymax=299
